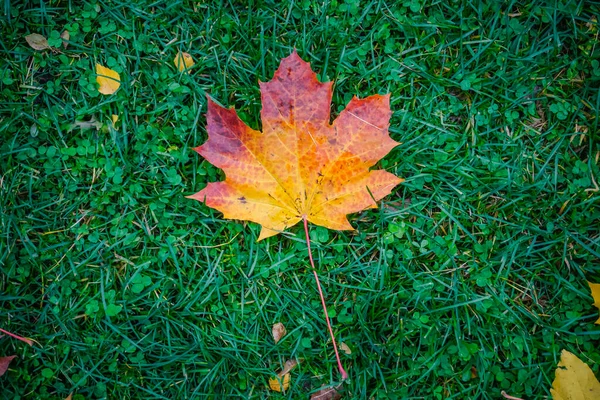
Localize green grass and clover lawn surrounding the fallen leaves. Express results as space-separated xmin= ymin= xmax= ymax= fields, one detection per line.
xmin=0 ymin=0 xmax=600 ymax=399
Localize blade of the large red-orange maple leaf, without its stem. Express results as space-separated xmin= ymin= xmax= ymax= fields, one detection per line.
xmin=190 ymin=51 xmax=403 ymax=240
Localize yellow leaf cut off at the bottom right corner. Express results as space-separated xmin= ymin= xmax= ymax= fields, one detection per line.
xmin=550 ymin=350 xmax=600 ymax=400
